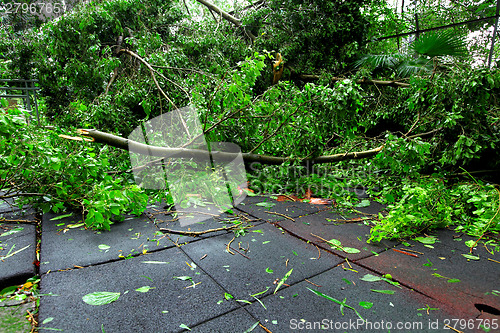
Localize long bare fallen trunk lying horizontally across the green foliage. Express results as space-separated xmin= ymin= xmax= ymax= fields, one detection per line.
xmin=73 ymin=129 xmax=384 ymax=165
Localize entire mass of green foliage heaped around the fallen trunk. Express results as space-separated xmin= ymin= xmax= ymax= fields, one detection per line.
xmin=0 ymin=0 xmax=500 ymax=245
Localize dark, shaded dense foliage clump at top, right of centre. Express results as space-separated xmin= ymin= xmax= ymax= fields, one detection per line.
xmin=250 ymin=0 xmax=380 ymax=73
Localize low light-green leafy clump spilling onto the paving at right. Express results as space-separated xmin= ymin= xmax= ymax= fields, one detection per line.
xmin=369 ymin=177 xmax=500 ymax=241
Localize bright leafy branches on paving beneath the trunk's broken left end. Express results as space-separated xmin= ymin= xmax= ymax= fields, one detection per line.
xmin=0 ymin=102 xmax=148 ymax=229
